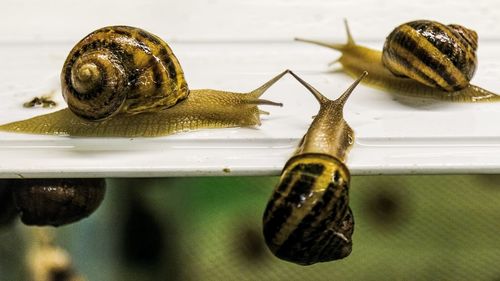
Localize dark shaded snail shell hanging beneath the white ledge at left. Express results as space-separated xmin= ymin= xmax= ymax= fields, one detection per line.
xmin=10 ymin=178 xmax=106 ymax=226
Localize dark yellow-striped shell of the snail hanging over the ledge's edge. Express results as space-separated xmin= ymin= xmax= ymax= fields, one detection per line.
xmin=263 ymin=153 xmax=354 ymax=265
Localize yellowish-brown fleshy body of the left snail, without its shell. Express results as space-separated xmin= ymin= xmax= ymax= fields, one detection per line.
xmin=0 ymin=86 xmax=281 ymax=137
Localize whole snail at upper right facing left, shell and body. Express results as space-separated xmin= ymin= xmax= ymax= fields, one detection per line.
xmin=296 ymin=20 xmax=500 ymax=102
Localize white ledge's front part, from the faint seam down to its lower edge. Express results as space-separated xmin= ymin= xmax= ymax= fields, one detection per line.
xmin=0 ymin=41 xmax=500 ymax=178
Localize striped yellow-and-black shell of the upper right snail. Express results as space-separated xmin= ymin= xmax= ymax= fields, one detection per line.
xmin=382 ymin=20 xmax=478 ymax=92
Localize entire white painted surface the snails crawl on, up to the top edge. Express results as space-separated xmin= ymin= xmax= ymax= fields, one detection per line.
xmin=0 ymin=0 xmax=500 ymax=178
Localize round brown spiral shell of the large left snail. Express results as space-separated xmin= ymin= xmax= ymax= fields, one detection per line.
xmin=61 ymin=26 xmax=189 ymax=121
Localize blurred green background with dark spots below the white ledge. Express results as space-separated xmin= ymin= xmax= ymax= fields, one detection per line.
xmin=0 ymin=175 xmax=500 ymax=281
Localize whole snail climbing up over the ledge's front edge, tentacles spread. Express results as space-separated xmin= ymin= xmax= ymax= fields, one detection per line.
xmin=263 ymin=72 xmax=367 ymax=265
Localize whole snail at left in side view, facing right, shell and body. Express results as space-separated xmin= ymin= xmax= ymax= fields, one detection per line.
xmin=0 ymin=26 xmax=286 ymax=137
